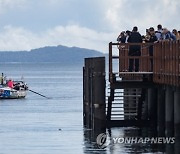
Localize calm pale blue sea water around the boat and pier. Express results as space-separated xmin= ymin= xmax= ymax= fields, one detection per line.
xmin=0 ymin=63 xmax=170 ymax=154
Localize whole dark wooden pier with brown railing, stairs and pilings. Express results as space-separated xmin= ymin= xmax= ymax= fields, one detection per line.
xmin=83 ymin=41 xmax=180 ymax=138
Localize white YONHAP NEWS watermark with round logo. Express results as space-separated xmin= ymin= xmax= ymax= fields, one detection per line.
xmin=96 ymin=133 xmax=175 ymax=148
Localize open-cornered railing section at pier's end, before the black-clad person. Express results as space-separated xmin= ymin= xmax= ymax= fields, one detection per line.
xmin=109 ymin=42 xmax=153 ymax=83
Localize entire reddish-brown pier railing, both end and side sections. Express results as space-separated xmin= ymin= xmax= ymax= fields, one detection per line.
xmin=109 ymin=41 xmax=180 ymax=86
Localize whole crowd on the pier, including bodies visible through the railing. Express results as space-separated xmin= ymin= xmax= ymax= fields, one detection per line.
xmin=117 ymin=24 xmax=180 ymax=72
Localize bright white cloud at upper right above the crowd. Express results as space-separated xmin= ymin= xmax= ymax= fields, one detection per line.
xmin=102 ymin=0 xmax=180 ymax=33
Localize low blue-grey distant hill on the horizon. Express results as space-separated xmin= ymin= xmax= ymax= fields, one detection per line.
xmin=0 ymin=45 xmax=104 ymax=64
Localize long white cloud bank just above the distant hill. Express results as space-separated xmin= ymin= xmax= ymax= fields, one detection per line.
xmin=0 ymin=25 xmax=114 ymax=52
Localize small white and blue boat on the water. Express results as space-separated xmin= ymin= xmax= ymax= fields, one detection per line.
xmin=0 ymin=81 xmax=28 ymax=99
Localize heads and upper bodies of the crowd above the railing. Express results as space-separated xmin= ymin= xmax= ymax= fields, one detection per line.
xmin=117 ymin=24 xmax=180 ymax=43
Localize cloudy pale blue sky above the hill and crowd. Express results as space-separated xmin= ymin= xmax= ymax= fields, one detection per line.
xmin=0 ymin=0 xmax=180 ymax=52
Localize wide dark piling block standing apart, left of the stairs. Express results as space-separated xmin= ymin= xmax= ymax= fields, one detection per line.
xmin=83 ymin=57 xmax=106 ymax=131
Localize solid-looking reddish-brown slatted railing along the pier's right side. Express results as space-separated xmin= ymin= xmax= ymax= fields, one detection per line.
xmin=153 ymin=40 xmax=180 ymax=86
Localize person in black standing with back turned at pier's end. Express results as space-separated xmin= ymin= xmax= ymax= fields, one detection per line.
xmin=128 ymin=26 xmax=142 ymax=72
